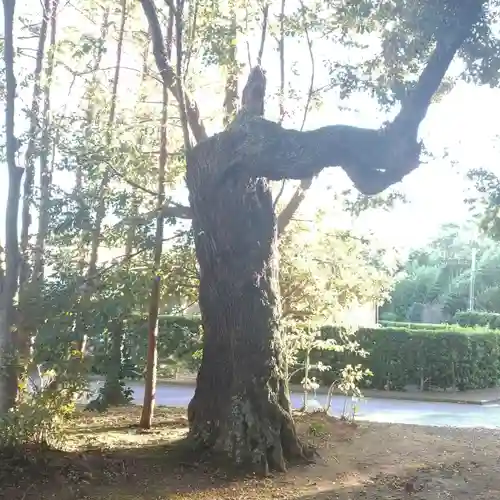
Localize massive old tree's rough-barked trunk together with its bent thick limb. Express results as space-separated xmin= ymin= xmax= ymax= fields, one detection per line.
xmin=141 ymin=0 xmax=484 ymax=471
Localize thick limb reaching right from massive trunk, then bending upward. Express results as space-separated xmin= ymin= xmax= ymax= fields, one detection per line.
xmin=213 ymin=2 xmax=482 ymax=195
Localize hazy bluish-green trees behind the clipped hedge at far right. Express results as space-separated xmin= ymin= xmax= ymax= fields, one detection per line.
xmin=382 ymin=225 xmax=500 ymax=322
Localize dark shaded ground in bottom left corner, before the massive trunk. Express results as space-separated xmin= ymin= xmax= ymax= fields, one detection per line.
xmin=0 ymin=440 xmax=254 ymax=500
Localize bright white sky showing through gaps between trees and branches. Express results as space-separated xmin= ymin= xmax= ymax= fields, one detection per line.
xmin=0 ymin=0 xmax=500 ymax=258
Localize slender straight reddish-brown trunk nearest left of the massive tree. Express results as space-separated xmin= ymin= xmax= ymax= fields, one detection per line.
xmin=139 ymin=12 xmax=173 ymax=429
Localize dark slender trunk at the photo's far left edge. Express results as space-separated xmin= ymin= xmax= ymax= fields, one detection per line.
xmin=0 ymin=0 xmax=24 ymax=415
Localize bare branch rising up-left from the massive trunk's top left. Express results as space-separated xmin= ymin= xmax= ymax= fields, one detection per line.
xmin=140 ymin=0 xmax=208 ymax=142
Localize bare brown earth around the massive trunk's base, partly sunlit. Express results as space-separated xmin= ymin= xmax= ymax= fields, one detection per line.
xmin=0 ymin=407 xmax=500 ymax=500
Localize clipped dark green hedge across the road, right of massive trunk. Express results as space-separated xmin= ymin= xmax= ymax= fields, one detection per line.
xmin=319 ymin=327 xmax=500 ymax=391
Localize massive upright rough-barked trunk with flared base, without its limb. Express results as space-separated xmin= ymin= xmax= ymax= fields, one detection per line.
xmin=187 ymin=167 xmax=304 ymax=471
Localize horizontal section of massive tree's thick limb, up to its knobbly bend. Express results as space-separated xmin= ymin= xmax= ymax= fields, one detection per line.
xmin=215 ymin=117 xmax=421 ymax=195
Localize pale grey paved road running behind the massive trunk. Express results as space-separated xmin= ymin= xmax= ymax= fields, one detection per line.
xmin=88 ymin=382 xmax=500 ymax=429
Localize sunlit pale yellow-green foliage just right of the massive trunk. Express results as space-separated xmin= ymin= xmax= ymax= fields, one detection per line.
xmin=280 ymin=216 xmax=394 ymax=322
